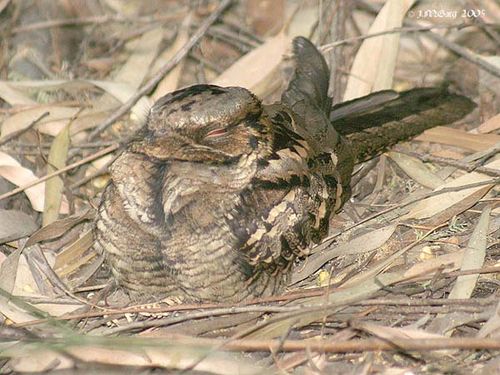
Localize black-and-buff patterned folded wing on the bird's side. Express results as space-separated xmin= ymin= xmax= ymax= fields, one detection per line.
xmin=232 ymin=112 xmax=337 ymax=269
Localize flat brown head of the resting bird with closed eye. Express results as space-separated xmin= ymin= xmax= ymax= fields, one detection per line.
xmin=135 ymin=85 xmax=270 ymax=162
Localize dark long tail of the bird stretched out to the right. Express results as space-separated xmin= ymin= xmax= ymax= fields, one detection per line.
xmin=330 ymin=88 xmax=475 ymax=163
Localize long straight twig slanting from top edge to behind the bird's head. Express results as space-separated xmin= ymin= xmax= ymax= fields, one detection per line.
xmin=89 ymin=0 xmax=232 ymax=140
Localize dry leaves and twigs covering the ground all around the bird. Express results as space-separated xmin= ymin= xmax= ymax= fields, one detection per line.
xmin=0 ymin=0 xmax=500 ymax=374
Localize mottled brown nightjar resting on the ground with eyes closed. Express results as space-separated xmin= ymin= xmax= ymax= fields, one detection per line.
xmin=95 ymin=37 xmax=473 ymax=302
